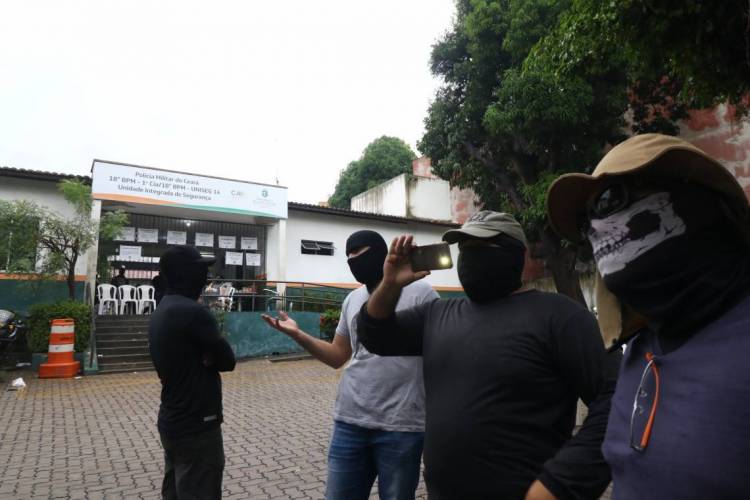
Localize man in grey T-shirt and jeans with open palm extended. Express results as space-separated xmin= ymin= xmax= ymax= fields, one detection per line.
xmin=264 ymin=231 xmax=438 ymax=500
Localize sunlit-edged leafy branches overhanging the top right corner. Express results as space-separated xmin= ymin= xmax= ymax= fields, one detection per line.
xmin=537 ymin=0 xmax=750 ymax=112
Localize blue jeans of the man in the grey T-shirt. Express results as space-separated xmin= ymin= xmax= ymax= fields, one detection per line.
xmin=326 ymin=422 xmax=424 ymax=500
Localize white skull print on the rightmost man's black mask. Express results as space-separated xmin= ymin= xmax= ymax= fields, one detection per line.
xmin=588 ymin=192 xmax=685 ymax=277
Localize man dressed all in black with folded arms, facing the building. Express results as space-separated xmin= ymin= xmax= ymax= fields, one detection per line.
xmin=148 ymin=246 xmax=235 ymax=499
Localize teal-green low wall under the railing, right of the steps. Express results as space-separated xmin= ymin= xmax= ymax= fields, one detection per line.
xmin=224 ymin=312 xmax=328 ymax=358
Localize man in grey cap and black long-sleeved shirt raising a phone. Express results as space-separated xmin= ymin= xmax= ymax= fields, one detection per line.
xmin=358 ymin=211 xmax=617 ymax=500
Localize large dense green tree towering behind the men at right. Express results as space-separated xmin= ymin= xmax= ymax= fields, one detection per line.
xmin=418 ymin=0 xmax=750 ymax=300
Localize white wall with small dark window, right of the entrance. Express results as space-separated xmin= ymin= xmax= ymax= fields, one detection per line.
xmin=284 ymin=207 xmax=461 ymax=287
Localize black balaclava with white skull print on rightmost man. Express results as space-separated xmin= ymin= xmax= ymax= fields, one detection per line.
xmin=588 ymin=184 xmax=750 ymax=340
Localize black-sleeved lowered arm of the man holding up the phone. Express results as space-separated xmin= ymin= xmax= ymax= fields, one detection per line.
xmin=539 ymin=310 xmax=621 ymax=499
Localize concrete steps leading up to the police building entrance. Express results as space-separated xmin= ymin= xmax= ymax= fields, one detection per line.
xmin=94 ymin=315 xmax=154 ymax=373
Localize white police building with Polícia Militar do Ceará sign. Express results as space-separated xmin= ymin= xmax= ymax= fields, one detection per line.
xmin=0 ymin=160 xmax=460 ymax=308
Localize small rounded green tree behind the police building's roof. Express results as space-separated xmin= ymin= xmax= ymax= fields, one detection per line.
xmin=328 ymin=135 xmax=417 ymax=208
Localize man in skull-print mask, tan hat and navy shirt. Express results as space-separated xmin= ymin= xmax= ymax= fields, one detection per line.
xmin=548 ymin=134 xmax=750 ymax=499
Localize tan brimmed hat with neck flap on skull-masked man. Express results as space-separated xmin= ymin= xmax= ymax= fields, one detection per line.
xmin=547 ymin=134 xmax=750 ymax=345
